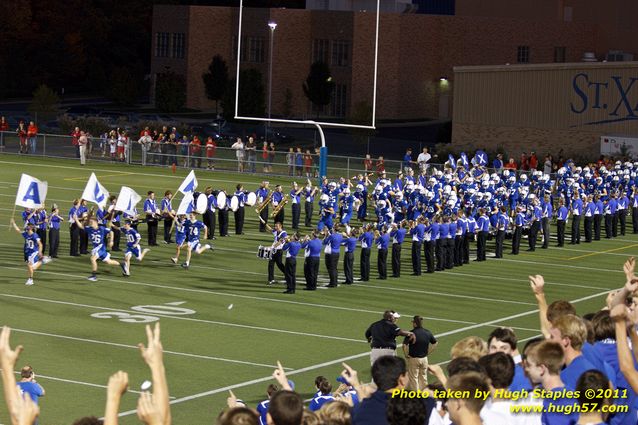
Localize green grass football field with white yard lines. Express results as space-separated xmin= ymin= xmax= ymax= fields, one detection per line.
xmin=0 ymin=155 xmax=638 ymax=425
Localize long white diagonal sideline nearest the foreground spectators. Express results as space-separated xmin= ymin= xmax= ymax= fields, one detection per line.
xmin=119 ymin=291 xmax=607 ymax=416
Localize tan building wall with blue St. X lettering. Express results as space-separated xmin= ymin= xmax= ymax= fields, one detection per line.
xmin=452 ymin=62 xmax=638 ymax=157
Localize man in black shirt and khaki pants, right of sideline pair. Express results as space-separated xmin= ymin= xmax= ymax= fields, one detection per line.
xmin=403 ymin=316 xmax=438 ymax=391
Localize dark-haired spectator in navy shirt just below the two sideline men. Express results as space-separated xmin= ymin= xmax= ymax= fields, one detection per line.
xmin=352 ymin=356 xmax=435 ymax=425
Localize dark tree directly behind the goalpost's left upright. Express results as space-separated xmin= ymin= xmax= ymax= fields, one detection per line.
xmin=221 ymin=68 xmax=266 ymax=120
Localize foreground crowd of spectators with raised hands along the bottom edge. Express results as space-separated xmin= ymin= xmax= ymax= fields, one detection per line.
xmin=0 ymin=257 xmax=638 ymax=425
